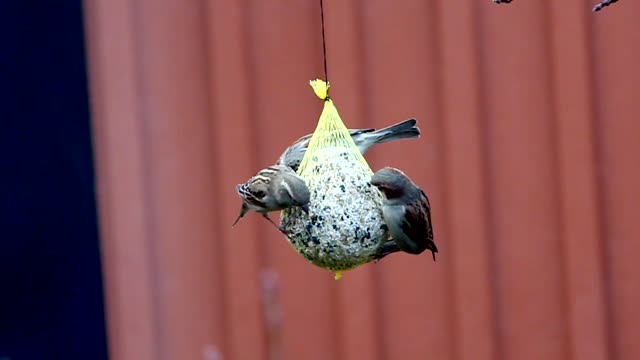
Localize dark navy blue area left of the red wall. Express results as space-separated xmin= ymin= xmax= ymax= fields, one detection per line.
xmin=0 ymin=0 xmax=107 ymax=360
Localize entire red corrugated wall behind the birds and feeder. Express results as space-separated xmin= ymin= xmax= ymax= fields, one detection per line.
xmin=85 ymin=0 xmax=640 ymax=360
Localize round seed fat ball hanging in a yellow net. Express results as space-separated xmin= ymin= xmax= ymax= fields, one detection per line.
xmin=280 ymin=79 xmax=388 ymax=279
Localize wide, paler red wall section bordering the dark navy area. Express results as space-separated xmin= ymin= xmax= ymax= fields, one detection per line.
xmin=87 ymin=2 xmax=222 ymax=359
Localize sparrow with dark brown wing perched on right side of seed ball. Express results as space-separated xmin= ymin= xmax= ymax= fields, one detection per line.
xmin=371 ymin=167 xmax=438 ymax=261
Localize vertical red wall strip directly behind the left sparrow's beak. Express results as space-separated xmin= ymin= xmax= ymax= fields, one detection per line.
xmin=207 ymin=0 xmax=268 ymax=360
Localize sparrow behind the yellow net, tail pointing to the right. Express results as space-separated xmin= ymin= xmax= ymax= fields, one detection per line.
xmin=276 ymin=119 xmax=420 ymax=171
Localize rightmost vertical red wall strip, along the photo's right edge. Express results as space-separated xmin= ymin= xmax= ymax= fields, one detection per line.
xmin=592 ymin=1 xmax=640 ymax=360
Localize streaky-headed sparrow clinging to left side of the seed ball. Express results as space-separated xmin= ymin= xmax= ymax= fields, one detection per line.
xmin=232 ymin=165 xmax=311 ymax=231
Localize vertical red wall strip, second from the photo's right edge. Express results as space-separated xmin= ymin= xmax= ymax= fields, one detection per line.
xmin=550 ymin=0 xmax=609 ymax=360
